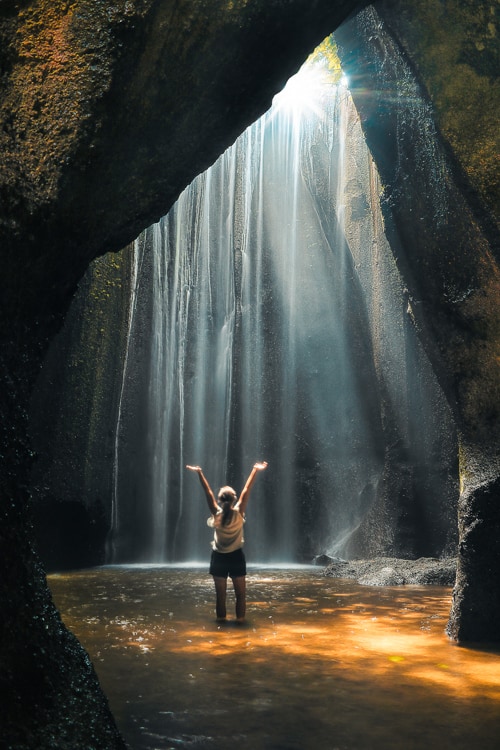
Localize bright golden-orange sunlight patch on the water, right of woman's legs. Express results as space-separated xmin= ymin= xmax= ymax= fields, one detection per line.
xmin=128 ymin=596 xmax=500 ymax=699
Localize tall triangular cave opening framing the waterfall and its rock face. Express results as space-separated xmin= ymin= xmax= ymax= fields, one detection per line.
xmin=31 ymin=36 xmax=458 ymax=569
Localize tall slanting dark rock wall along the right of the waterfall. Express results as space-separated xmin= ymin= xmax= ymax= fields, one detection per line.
xmin=336 ymin=3 xmax=500 ymax=640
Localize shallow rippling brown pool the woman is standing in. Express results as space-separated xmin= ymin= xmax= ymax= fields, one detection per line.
xmin=49 ymin=567 xmax=500 ymax=750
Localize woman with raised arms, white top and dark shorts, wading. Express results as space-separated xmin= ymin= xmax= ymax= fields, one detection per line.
xmin=186 ymin=461 xmax=267 ymax=622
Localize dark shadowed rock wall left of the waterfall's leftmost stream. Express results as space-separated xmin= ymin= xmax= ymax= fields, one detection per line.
xmin=30 ymin=246 xmax=137 ymax=571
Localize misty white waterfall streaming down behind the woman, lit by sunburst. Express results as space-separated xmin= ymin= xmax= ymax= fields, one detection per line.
xmin=110 ymin=42 xmax=458 ymax=562
